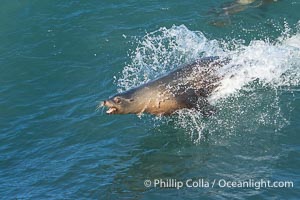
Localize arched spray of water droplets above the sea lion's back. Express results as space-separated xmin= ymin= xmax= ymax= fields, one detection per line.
xmin=117 ymin=25 xmax=223 ymax=92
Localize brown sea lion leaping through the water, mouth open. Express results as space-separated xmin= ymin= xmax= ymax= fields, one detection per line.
xmin=101 ymin=57 xmax=224 ymax=116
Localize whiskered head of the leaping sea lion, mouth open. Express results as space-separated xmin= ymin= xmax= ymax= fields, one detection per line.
xmin=102 ymin=94 xmax=138 ymax=114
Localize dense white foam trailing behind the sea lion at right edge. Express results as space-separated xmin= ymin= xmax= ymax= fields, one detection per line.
xmin=211 ymin=35 xmax=300 ymax=100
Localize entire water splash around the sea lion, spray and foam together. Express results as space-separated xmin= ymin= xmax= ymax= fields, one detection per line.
xmin=117 ymin=25 xmax=300 ymax=143
